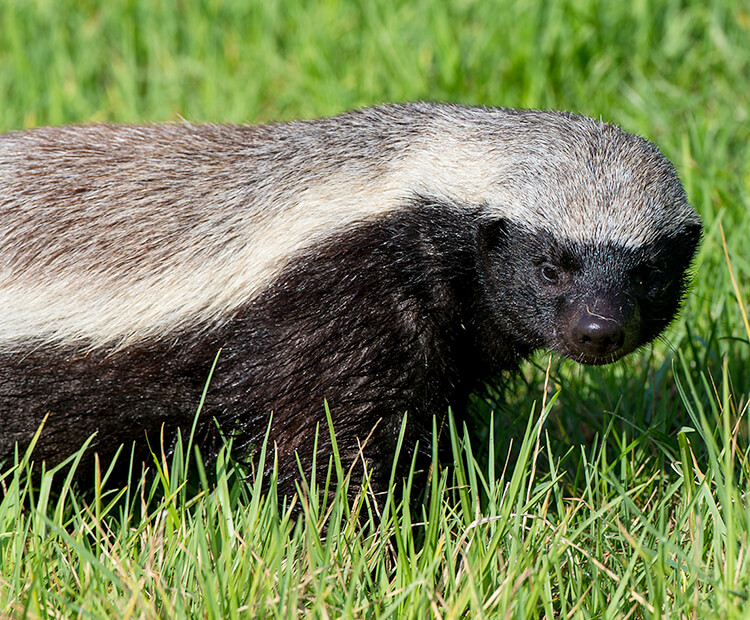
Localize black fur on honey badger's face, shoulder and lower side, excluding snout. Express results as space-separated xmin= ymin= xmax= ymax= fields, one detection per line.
xmin=0 ymin=198 xmax=700 ymax=492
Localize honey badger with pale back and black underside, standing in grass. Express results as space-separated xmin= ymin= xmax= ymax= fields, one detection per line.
xmin=0 ymin=103 xmax=701 ymax=490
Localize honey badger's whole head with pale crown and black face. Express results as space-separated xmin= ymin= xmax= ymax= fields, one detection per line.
xmin=412 ymin=106 xmax=701 ymax=364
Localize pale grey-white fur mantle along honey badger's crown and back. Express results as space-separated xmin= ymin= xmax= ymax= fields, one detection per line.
xmin=0 ymin=104 xmax=699 ymax=347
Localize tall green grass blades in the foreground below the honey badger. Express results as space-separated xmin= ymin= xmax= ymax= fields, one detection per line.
xmin=0 ymin=372 xmax=750 ymax=618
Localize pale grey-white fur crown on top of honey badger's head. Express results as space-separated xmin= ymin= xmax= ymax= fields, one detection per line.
xmin=410 ymin=103 xmax=699 ymax=247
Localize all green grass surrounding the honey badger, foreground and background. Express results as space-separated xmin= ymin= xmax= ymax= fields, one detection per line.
xmin=0 ymin=0 xmax=750 ymax=618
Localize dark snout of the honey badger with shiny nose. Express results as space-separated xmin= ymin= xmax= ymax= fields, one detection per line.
xmin=561 ymin=295 xmax=640 ymax=364
